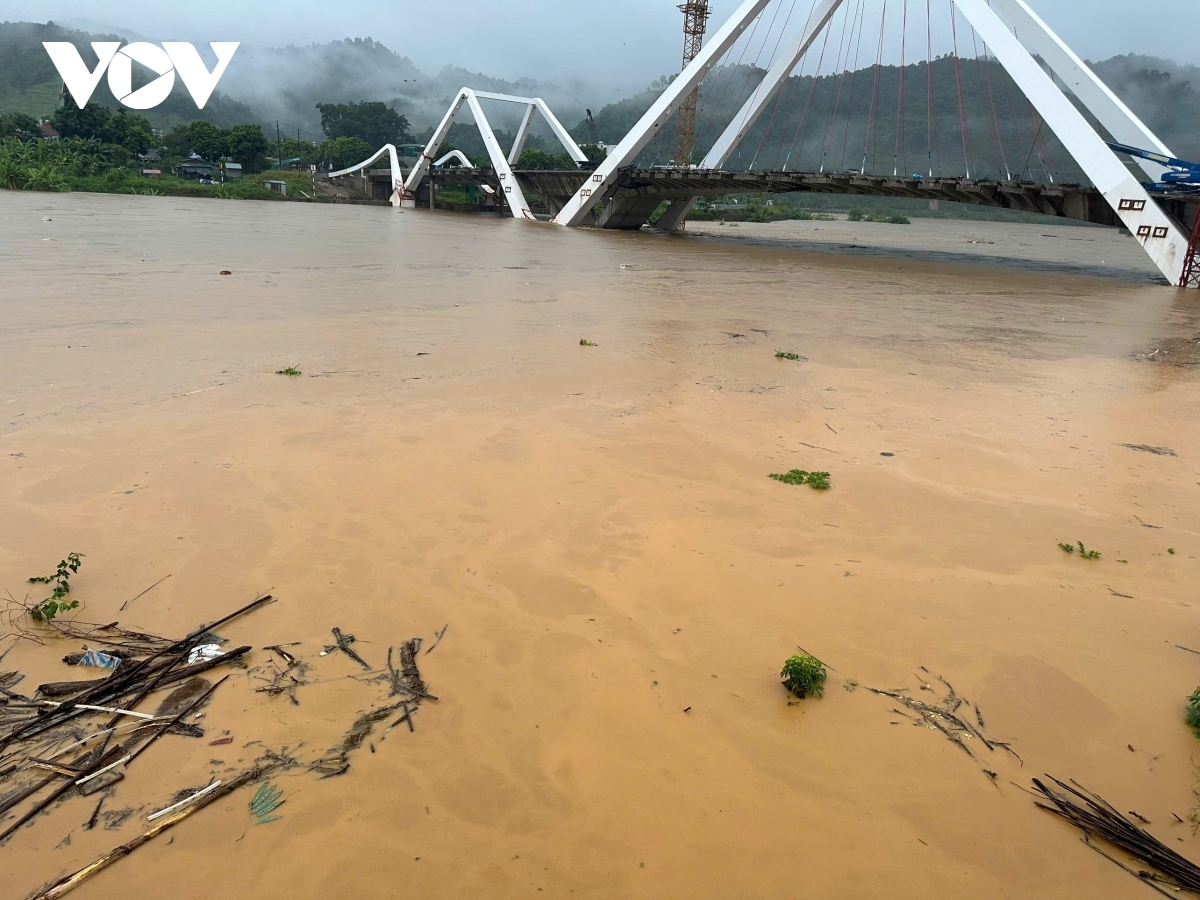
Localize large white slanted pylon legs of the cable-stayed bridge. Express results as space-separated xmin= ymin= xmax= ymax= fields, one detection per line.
xmin=553 ymin=0 xmax=1188 ymax=284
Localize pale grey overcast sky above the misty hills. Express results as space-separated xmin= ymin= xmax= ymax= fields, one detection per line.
xmin=0 ymin=0 xmax=1200 ymax=89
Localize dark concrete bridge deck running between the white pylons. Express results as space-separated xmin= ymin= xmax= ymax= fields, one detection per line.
xmin=410 ymin=168 xmax=1196 ymax=234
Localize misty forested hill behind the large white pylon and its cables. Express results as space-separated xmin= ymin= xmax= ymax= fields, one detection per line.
xmin=571 ymin=56 xmax=1200 ymax=181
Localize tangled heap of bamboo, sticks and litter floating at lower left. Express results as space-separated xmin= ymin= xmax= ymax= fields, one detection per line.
xmin=0 ymin=594 xmax=445 ymax=900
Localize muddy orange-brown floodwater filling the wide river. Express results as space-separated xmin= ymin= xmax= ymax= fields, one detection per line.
xmin=0 ymin=192 xmax=1200 ymax=900
